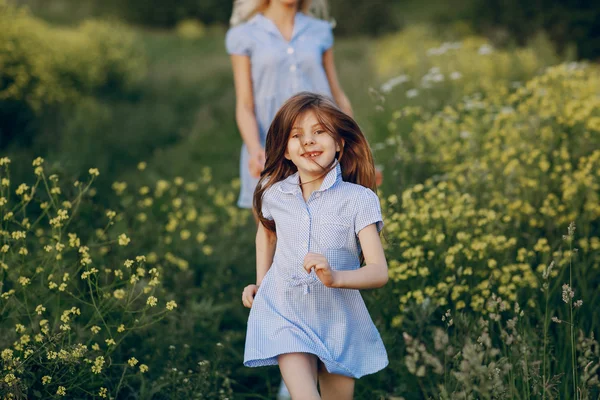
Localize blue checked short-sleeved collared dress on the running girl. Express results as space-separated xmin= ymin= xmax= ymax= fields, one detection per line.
xmin=244 ymin=164 xmax=388 ymax=378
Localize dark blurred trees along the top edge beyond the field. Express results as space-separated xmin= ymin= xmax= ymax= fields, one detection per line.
xmin=9 ymin=0 xmax=600 ymax=59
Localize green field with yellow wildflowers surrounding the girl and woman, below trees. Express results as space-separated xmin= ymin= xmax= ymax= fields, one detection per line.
xmin=0 ymin=4 xmax=600 ymax=400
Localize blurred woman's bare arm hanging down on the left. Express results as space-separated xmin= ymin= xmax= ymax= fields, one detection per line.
xmin=231 ymin=54 xmax=265 ymax=177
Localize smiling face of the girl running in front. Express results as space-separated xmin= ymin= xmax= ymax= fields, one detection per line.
xmin=285 ymin=111 xmax=340 ymax=179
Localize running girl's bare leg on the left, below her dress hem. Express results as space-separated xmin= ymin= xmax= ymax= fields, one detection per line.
xmin=277 ymin=353 xmax=321 ymax=400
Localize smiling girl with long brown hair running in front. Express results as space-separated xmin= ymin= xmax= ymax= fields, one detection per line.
xmin=242 ymin=92 xmax=388 ymax=400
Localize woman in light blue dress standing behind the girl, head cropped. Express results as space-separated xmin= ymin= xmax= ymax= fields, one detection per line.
xmin=225 ymin=0 xmax=352 ymax=208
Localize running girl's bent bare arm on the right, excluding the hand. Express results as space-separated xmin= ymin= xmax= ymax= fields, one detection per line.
xmin=332 ymin=224 xmax=388 ymax=289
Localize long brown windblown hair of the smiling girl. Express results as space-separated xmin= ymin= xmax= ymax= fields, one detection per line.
xmin=253 ymin=92 xmax=376 ymax=232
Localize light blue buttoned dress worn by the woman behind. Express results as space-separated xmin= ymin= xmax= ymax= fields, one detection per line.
xmin=225 ymin=12 xmax=333 ymax=208
